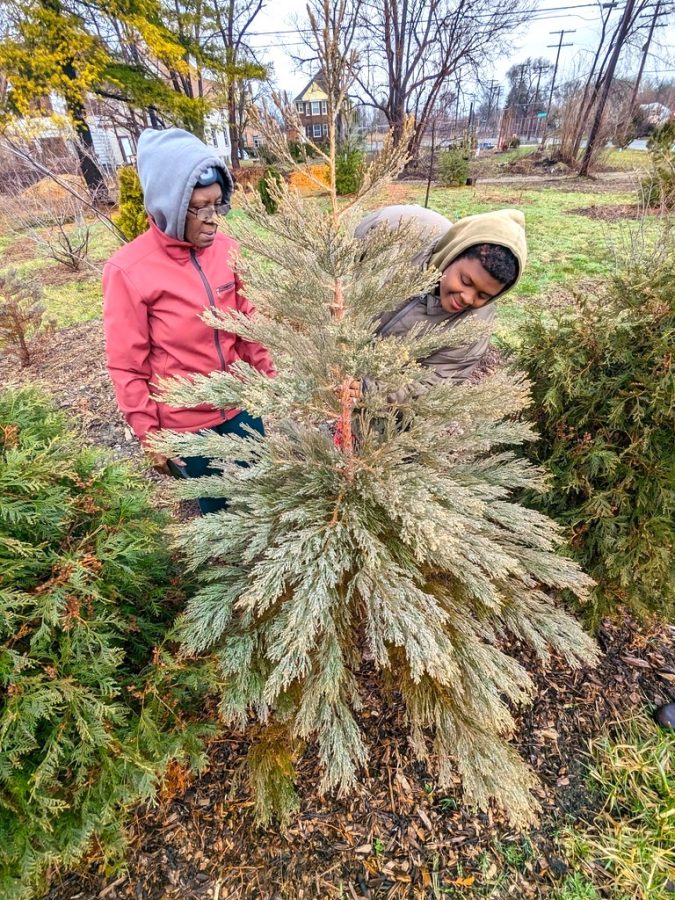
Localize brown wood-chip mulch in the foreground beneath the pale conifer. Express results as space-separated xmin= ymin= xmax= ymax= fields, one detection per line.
xmin=47 ymin=621 xmax=675 ymax=900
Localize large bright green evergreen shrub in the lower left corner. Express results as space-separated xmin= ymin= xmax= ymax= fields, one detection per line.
xmin=0 ymin=390 xmax=214 ymax=898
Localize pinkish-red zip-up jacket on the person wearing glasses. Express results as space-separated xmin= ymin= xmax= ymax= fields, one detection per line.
xmin=103 ymin=219 xmax=274 ymax=442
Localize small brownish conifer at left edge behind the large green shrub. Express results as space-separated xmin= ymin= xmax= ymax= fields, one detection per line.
xmin=0 ymin=269 xmax=52 ymax=368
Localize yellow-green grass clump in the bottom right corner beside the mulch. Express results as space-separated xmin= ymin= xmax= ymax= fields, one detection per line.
xmin=566 ymin=716 xmax=675 ymax=900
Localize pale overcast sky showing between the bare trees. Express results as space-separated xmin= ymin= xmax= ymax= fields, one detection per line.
xmin=246 ymin=0 xmax=675 ymax=107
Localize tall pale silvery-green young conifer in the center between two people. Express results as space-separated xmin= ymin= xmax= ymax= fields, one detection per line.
xmin=152 ymin=19 xmax=595 ymax=825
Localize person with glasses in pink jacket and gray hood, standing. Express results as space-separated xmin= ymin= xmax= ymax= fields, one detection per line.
xmin=103 ymin=128 xmax=274 ymax=512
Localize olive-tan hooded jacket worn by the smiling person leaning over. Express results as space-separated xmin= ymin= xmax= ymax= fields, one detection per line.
xmin=355 ymin=205 xmax=527 ymax=402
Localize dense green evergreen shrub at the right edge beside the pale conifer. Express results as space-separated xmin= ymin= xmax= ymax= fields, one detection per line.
xmin=519 ymin=228 xmax=675 ymax=618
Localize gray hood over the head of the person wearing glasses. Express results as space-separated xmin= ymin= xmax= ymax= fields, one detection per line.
xmin=137 ymin=128 xmax=234 ymax=241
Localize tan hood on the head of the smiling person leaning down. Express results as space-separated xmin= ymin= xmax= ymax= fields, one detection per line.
xmin=429 ymin=209 xmax=527 ymax=297
